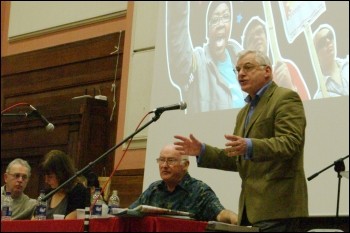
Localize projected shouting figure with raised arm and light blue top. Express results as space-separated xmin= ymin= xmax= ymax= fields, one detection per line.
xmin=166 ymin=1 xmax=245 ymax=112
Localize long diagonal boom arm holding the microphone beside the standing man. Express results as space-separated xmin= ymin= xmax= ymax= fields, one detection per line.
xmin=42 ymin=112 xmax=163 ymax=201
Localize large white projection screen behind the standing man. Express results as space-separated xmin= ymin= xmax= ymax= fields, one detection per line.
xmin=143 ymin=1 xmax=349 ymax=216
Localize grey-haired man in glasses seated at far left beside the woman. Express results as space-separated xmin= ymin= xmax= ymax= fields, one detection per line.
xmin=1 ymin=159 xmax=36 ymax=220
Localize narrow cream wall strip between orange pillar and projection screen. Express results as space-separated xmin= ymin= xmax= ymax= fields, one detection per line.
xmin=124 ymin=1 xmax=159 ymax=149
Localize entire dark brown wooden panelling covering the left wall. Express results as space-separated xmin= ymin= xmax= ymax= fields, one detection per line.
xmin=1 ymin=32 xmax=125 ymax=196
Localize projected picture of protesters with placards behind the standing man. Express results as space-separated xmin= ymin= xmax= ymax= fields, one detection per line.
xmin=165 ymin=1 xmax=349 ymax=113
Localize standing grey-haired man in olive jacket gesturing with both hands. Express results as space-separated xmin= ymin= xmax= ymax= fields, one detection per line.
xmin=174 ymin=51 xmax=308 ymax=232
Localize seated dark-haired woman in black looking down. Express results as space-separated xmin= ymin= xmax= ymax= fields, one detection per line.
xmin=41 ymin=150 xmax=90 ymax=219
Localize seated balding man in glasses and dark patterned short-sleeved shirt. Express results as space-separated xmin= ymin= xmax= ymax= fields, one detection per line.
xmin=129 ymin=145 xmax=238 ymax=224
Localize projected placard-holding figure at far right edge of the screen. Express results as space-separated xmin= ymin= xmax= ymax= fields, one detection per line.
xmin=313 ymin=24 xmax=349 ymax=99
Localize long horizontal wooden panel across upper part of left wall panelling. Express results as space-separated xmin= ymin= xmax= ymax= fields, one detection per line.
xmin=2 ymin=51 xmax=121 ymax=111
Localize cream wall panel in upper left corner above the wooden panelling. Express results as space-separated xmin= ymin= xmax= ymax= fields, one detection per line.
xmin=9 ymin=1 xmax=127 ymax=40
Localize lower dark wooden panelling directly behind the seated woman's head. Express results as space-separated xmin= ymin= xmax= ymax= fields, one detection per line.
xmin=1 ymin=98 xmax=110 ymax=198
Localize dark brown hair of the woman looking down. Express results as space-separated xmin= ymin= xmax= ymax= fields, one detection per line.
xmin=41 ymin=150 xmax=76 ymax=192
